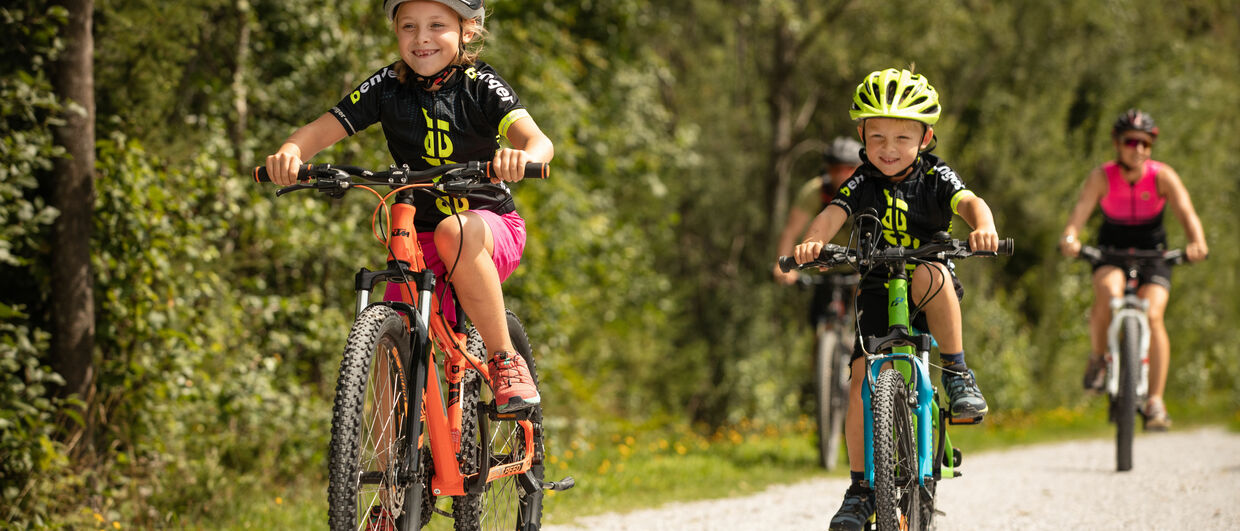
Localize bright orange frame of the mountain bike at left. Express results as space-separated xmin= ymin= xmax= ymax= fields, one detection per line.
xmin=356 ymin=185 xmax=534 ymax=496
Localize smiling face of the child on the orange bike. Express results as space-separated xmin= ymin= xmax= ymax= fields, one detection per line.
xmin=392 ymin=1 xmax=474 ymax=76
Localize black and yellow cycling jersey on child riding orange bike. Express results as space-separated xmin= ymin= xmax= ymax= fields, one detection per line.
xmin=331 ymin=61 xmax=529 ymax=232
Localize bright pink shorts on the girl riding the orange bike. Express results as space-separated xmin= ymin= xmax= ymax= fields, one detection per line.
xmin=383 ymin=210 xmax=526 ymax=324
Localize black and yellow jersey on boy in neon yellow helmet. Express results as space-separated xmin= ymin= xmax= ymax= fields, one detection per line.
xmin=831 ymin=154 xmax=973 ymax=253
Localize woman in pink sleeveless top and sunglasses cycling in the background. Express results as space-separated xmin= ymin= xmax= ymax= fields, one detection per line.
xmin=1059 ymin=109 xmax=1209 ymax=431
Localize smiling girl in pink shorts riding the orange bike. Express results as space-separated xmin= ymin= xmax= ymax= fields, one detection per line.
xmin=267 ymin=0 xmax=554 ymax=412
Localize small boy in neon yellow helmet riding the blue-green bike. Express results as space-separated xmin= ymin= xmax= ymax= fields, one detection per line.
xmin=795 ymin=68 xmax=998 ymax=530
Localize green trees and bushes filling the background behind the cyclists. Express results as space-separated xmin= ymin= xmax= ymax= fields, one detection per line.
xmin=0 ymin=0 xmax=1240 ymax=527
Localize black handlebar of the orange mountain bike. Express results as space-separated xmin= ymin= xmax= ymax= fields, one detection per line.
xmin=254 ymin=161 xmax=551 ymax=195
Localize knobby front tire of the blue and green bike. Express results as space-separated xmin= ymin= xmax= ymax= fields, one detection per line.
xmin=872 ymin=368 xmax=921 ymax=531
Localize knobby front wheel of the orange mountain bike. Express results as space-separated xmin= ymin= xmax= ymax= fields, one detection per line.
xmin=327 ymin=305 xmax=429 ymax=531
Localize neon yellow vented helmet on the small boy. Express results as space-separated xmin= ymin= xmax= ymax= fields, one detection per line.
xmin=848 ymin=68 xmax=941 ymax=125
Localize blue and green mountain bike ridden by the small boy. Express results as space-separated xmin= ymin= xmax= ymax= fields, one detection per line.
xmin=780 ymin=215 xmax=1013 ymax=531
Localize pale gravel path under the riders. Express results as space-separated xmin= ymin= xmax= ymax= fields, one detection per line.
xmin=546 ymin=428 xmax=1240 ymax=531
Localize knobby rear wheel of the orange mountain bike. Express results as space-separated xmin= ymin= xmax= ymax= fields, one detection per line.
xmin=453 ymin=311 xmax=544 ymax=531
